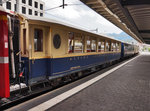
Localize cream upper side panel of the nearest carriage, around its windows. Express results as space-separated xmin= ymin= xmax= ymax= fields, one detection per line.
xmin=18 ymin=15 xmax=121 ymax=59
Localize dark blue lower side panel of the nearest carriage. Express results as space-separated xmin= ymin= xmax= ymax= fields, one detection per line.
xmin=23 ymin=53 xmax=121 ymax=84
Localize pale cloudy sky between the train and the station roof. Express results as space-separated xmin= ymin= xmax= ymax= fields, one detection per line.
xmin=43 ymin=0 xmax=138 ymax=42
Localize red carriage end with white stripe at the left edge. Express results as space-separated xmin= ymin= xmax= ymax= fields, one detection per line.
xmin=0 ymin=11 xmax=10 ymax=98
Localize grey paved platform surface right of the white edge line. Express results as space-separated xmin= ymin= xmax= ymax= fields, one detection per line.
xmin=5 ymin=55 xmax=150 ymax=111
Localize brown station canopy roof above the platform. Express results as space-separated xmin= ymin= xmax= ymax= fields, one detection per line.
xmin=80 ymin=0 xmax=150 ymax=44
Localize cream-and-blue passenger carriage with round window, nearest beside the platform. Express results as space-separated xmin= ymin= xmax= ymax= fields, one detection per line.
xmin=21 ymin=14 xmax=121 ymax=84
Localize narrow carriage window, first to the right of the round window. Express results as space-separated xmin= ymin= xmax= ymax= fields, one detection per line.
xmin=68 ymin=32 xmax=74 ymax=53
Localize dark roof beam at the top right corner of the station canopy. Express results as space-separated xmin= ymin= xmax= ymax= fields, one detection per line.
xmin=121 ymin=0 xmax=150 ymax=6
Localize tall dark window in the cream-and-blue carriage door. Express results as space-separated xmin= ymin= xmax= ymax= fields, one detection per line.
xmin=34 ymin=29 xmax=43 ymax=52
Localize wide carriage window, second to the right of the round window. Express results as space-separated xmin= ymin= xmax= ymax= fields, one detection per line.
xmin=74 ymin=37 xmax=84 ymax=53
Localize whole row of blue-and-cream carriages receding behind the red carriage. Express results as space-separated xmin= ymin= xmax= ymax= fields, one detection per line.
xmin=0 ymin=8 xmax=139 ymax=97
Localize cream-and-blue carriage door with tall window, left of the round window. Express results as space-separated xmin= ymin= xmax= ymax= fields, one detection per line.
xmin=30 ymin=27 xmax=48 ymax=81
